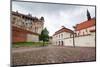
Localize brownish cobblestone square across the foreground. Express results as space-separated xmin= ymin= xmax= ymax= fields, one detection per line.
xmin=12 ymin=46 xmax=96 ymax=65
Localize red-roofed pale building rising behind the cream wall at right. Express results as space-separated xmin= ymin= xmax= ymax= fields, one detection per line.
xmin=74 ymin=18 xmax=95 ymax=36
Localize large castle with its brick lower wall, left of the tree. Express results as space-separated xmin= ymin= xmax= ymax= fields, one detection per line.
xmin=11 ymin=11 xmax=44 ymax=42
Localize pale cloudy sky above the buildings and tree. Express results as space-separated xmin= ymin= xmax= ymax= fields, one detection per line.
xmin=12 ymin=1 xmax=95 ymax=36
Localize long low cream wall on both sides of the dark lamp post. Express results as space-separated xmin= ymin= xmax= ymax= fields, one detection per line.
xmin=64 ymin=34 xmax=95 ymax=47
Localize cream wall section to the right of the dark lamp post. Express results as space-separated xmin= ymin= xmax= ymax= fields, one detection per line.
xmin=75 ymin=35 xmax=95 ymax=47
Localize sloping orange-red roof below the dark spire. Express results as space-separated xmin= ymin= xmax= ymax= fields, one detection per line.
xmin=75 ymin=18 xmax=96 ymax=31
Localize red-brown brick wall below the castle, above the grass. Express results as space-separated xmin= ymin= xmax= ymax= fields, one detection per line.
xmin=12 ymin=26 xmax=38 ymax=43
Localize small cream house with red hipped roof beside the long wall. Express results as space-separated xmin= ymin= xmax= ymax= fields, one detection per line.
xmin=53 ymin=26 xmax=73 ymax=45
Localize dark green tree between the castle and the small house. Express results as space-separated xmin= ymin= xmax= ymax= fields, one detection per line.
xmin=39 ymin=28 xmax=49 ymax=46
